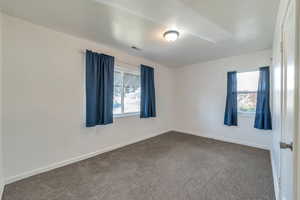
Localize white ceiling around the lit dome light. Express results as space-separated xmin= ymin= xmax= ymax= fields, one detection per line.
xmin=0 ymin=0 xmax=279 ymax=67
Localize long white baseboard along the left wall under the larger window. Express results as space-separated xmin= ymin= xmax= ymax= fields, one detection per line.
xmin=5 ymin=130 xmax=170 ymax=184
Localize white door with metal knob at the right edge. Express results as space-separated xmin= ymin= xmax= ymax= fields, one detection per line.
xmin=280 ymin=0 xmax=297 ymax=200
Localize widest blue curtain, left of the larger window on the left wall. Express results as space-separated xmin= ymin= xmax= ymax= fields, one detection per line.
xmin=86 ymin=50 xmax=114 ymax=127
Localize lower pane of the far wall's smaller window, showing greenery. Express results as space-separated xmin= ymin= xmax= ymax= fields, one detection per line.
xmin=237 ymin=92 xmax=257 ymax=113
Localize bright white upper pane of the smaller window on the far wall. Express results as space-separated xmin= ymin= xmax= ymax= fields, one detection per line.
xmin=237 ymin=71 xmax=259 ymax=92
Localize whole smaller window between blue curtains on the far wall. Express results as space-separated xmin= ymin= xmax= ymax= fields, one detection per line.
xmin=237 ymin=71 xmax=259 ymax=114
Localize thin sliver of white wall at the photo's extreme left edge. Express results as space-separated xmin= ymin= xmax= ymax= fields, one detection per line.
xmin=0 ymin=12 xmax=4 ymax=199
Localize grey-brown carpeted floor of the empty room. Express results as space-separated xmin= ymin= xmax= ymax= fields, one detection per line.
xmin=3 ymin=132 xmax=275 ymax=200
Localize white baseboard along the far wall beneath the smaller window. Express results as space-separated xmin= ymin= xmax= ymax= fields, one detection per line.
xmin=174 ymin=130 xmax=270 ymax=150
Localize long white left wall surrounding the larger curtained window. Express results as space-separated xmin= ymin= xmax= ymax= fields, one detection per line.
xmin=3 ymin=15 xmax=173 ymax=182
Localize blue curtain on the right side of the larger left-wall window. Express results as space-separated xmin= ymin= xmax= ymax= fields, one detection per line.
xmin=140 ymin=65 xmax=156 ymax=118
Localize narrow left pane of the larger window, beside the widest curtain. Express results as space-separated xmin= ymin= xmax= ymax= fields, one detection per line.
xmin=113 ymin=71 xmax=123 ymax=114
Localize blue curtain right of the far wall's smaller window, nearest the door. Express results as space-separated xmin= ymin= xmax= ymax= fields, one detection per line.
xmin=254 ymin=67 xmax=272 ymax=130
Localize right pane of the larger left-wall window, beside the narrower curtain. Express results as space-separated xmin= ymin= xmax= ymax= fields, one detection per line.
xmin=124 ymin=73 xmax=141 ymax=113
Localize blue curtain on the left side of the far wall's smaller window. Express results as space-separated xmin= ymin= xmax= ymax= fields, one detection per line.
xmin=224 ymin=72 xmax=238 ymax=126
